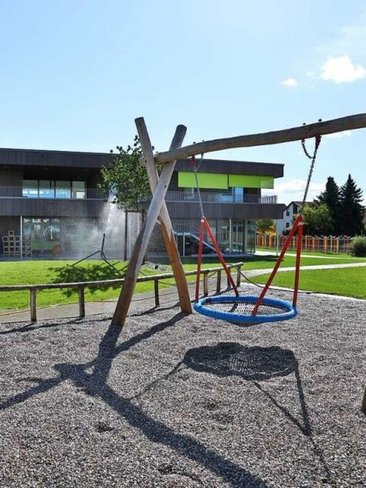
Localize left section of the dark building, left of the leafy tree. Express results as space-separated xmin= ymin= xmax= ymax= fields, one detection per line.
xmin=0 ymin=149 xmax=136 ymax=257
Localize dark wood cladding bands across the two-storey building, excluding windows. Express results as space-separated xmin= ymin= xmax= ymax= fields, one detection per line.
xmin=0 ymin=149 xmax=284 ymax=258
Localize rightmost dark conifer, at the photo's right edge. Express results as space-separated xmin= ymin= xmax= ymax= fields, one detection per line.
xmin=339 ymin=175 xmax=365 ymax=236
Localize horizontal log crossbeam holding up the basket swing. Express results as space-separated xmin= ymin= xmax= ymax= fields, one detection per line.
xmin=155 ymin=114 xmax=366 ymax=164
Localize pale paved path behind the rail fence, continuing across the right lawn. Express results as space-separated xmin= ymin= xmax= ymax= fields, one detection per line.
xmin=0 ymin=262 xmax=366 ymax=324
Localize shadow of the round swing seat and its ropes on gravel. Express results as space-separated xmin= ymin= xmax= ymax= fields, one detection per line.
xmin=183 ymin=342 xmax=332 ymax=481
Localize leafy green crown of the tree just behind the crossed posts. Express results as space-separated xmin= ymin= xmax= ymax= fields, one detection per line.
xmin=101 ymin=136 xmax=151 ymax=211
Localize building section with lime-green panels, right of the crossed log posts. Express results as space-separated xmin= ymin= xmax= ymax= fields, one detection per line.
xmin=161 ymin=159 xmax=285 ymax=255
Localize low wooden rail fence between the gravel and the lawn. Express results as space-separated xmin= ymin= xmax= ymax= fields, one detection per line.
xmin=0 ymin=262 xmax=243 ymax=322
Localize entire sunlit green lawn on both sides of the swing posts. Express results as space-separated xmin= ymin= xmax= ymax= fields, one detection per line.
xmin=0 ymin=254 xmax=366 ymax=310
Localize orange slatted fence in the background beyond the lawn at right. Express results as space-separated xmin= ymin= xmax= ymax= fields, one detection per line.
xmin=256 ymin=234 xmax=352 ymax=254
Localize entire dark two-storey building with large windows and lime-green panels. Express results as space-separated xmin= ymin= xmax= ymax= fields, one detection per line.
xmin=0 ymin=149 xmax=284 ymax=258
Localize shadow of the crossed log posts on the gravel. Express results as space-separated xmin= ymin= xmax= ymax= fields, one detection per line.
xmin=0 ymin=313 xmax=267 ymax=488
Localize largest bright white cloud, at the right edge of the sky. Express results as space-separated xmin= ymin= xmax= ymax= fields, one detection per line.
xmin=320 ymin=55 xmax=366 ymax=83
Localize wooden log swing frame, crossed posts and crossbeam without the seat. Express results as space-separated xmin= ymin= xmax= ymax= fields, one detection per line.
xmin=112 ymin=114 xmax=366 ymax=327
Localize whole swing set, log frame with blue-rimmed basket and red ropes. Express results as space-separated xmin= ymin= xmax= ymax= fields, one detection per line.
xmin=112 ymin=114 xmax=366 ymax=327
